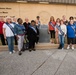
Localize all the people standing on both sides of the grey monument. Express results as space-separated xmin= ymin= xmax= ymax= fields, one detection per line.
xmin=0 ymin=15 xmax=76 ymax=55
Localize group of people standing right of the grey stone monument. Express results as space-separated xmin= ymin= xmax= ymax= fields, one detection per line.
xmin=48 ymin=15 xmax=76 ymax=50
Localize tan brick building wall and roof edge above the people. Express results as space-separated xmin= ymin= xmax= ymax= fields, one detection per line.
xmin=0 ymin=0 xmax=76 ymax=24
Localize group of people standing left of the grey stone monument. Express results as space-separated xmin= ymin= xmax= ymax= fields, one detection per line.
xmin=0 ymin=16 xmax=40 ymax=55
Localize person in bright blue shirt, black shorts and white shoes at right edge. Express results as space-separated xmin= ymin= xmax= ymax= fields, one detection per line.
xmin=67 ymin=19 xmax=76 ymax=50
